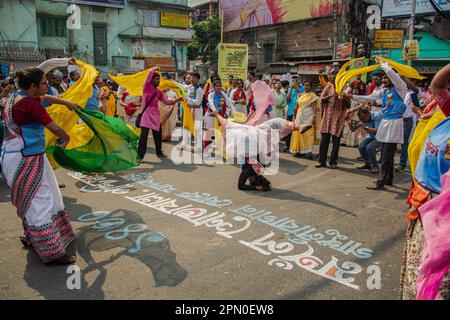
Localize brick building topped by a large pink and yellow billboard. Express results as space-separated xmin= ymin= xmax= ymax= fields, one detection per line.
xmin=221 ymin=0 xmax=368 ymax=79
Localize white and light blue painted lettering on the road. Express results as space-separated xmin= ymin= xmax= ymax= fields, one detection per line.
xmin=69 ymin=173 xmax=373 ymax=289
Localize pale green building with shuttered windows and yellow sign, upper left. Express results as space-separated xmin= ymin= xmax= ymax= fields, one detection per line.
xmin=0 ymin=0 xmax=192 ymax=74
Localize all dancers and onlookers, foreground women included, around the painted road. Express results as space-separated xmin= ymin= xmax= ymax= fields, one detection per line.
xmin=0 ymin=58 xmax=450 ymax=299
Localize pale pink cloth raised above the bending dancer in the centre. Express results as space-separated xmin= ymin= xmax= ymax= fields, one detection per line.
xmin=246 ymin=80 xmax=275 ymax=127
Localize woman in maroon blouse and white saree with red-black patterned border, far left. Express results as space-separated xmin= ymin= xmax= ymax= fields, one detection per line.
xmin=1 ymin=68 xmax=77 ymax=264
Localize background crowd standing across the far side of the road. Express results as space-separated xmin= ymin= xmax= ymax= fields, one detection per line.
xmin=0 ymin=58 xmax=446 ymax=195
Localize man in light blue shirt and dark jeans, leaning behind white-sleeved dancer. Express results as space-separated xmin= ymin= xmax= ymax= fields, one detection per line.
xmin=352 ymin=109 xmax=382 ymax=173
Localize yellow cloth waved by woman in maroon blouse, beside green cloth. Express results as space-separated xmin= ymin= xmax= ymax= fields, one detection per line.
xmin=45 ymin=60 xmax=98 ymax=169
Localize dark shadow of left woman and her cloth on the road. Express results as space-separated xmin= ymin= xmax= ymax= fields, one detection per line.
xmin=24 ymin=197 xmax=187 ymax=299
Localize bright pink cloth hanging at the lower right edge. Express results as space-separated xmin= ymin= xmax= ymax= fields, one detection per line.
xmin=416 ymin=170 xmax=450 ymax=300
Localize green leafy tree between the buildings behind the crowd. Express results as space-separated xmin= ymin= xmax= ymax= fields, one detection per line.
xmin=188 ymin=15 xmax=220 ymax=63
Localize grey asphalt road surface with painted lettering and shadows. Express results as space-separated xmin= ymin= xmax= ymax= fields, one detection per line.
xmin=0 ymin=141 xmax=409 ymax=299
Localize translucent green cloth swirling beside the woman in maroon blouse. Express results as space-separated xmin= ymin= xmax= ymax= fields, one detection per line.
xmin=47 ymin=108 xmax=140 ymax=173
